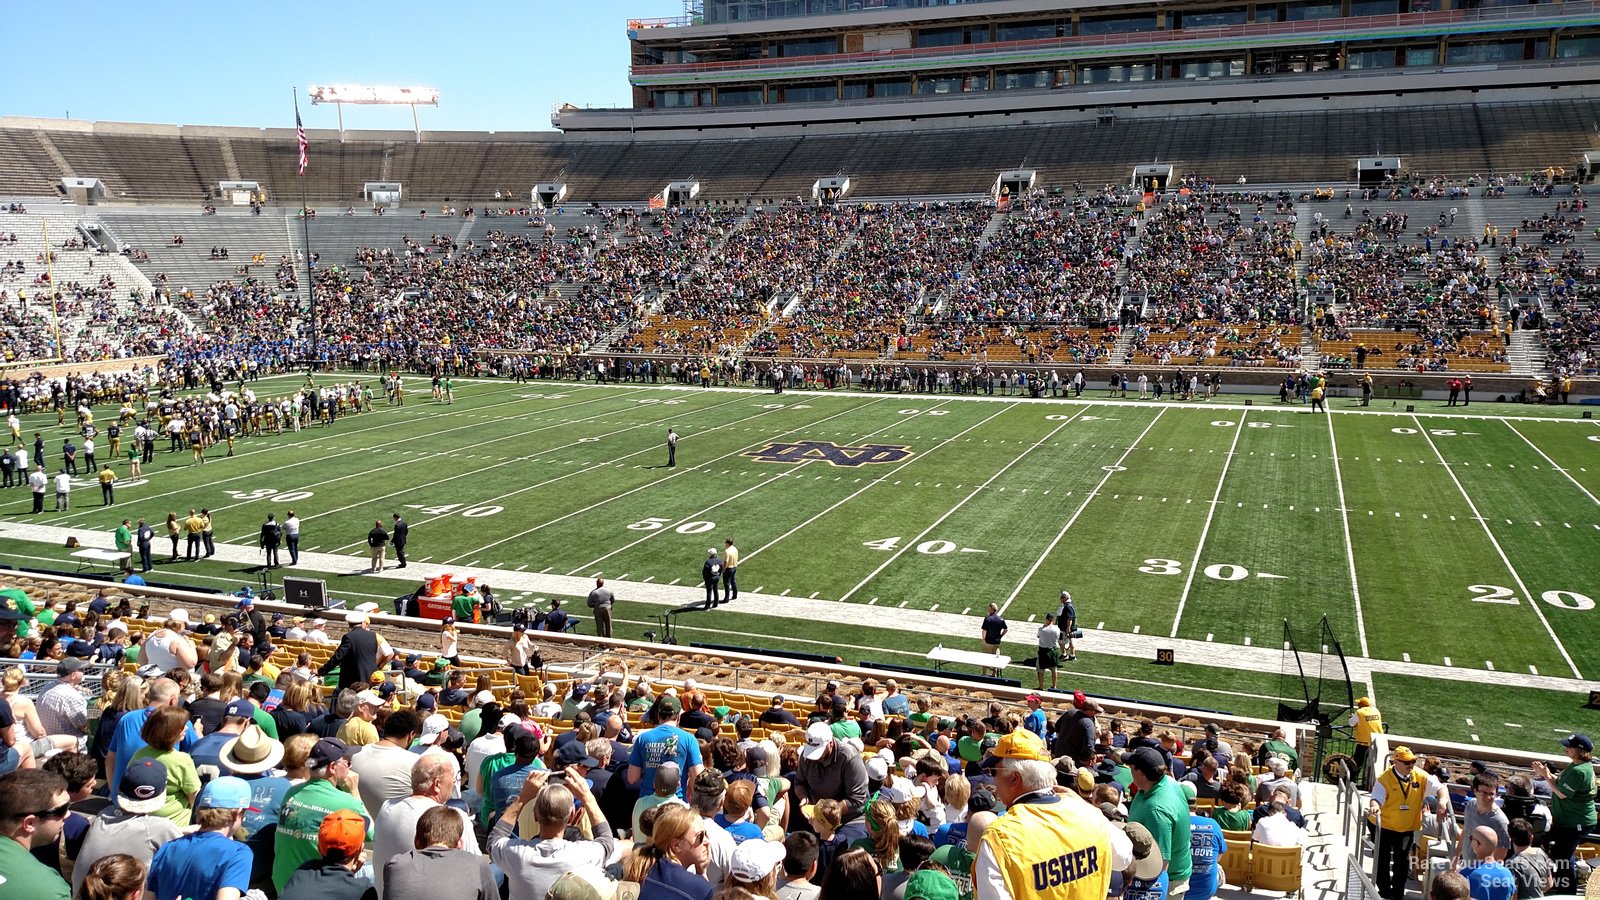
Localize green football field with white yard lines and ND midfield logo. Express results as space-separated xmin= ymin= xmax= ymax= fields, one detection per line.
xmin=0 ymin=380 xmax=1600 ymax=749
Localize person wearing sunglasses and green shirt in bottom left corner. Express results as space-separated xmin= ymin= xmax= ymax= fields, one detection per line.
xmin=0 ymin=769 xmax=72 ymax=900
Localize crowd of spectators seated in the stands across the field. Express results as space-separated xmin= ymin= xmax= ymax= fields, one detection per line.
xmin=9 ymin=184 xmax=1600 ymax=376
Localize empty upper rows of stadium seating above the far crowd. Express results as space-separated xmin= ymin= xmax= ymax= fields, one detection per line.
xmin=9 ymin=101 xmax=1597 ymax=205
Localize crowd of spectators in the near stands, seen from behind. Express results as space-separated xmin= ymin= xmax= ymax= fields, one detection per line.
xmin=0 ymin=591 xmax=1595 ymax=900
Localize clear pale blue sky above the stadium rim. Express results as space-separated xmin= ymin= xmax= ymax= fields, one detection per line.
xmin=0 ymin=0 xmax=683 ymax=131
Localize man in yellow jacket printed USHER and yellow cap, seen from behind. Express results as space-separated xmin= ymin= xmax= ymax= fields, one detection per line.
xmin=973 ymin=729 xmax=1133 ymax=900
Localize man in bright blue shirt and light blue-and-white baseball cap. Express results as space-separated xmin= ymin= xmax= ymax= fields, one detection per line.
xmin=145 ymin=767 xmax=254 ymax=900
